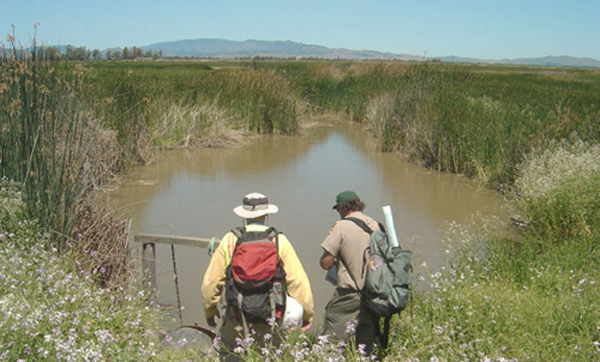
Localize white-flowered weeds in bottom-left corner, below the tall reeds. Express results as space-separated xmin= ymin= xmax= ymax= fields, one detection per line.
xmin=0 ymin=181 xmax=158 ymax=361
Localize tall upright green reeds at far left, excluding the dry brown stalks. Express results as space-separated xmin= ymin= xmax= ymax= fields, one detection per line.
xmin=0 ymin=44 xmax=93 ymax=245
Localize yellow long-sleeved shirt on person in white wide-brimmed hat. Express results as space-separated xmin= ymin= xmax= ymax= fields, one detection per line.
xmin=202 ymin=223 xmax=314 ymax=321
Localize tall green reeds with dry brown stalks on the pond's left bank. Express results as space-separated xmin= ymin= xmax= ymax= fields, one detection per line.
xmin=0 ymin=39 xmax=137 ymax=287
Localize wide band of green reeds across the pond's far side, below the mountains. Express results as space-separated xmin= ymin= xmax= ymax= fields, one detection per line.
xmin=92 ymin=61 xmax=600 ymax=188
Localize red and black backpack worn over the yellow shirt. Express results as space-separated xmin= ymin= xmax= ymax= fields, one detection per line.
xmin=225 ymin=227 xmax=286 ymax=323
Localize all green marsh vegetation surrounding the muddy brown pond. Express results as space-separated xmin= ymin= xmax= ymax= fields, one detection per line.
xmin=0 ymin=39 xmax=600 ymax=361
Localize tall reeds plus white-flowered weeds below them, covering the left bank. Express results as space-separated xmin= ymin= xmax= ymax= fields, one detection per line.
xmin=0 ymin=37 xmax=158 ymax=361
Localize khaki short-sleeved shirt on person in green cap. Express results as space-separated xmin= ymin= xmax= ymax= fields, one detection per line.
xmin=321 ymin=211 xmax=379 ymax=289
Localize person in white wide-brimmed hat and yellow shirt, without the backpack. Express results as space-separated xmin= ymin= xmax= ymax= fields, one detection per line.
xmin=202 ymin=192 xmax=313 ymax=358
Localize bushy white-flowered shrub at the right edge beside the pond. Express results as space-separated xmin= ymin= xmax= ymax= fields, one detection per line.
xmin=514 ymin=134 xmax=600 ymax=245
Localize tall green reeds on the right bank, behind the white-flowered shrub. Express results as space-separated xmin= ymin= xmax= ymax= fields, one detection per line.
xmin=366 ymin=65 xmax=600 ymax=187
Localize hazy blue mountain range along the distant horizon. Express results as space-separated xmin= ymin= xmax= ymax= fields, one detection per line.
xmin=141 ymin=39 xmax=600 ymax=67
